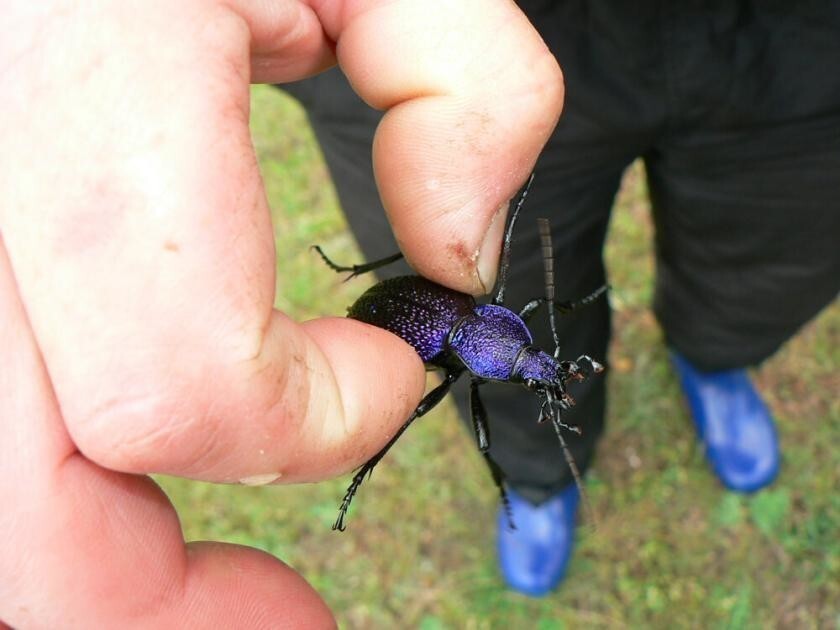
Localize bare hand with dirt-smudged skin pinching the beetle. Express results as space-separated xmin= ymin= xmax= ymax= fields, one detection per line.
xmin=0 ymin=0 xmax=563 ymax=628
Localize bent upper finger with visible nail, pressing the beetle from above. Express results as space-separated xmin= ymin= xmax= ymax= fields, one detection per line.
xmin=320 ymin=0 xmax=563 ymax=294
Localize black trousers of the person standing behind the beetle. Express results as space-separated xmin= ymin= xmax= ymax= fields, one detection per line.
xmin=284 ymin=0 xmax=840 ymax=502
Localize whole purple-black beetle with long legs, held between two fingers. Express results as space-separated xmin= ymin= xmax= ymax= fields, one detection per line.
xmin=313 ymin=175 xmax=607 ymax=531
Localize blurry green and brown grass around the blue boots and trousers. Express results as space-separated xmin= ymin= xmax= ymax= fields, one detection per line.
xmin=162 ymin=87 xmax=840 ymax=630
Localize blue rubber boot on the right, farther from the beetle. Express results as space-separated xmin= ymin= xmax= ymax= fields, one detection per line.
xmin=671 ymin=352 xmax=781 ymax=492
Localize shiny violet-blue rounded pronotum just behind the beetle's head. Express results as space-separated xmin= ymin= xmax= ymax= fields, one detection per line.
xmin=450 ymin=304 xmax=533 ymax=381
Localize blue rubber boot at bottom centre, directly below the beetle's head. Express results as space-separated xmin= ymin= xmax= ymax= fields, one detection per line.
xmin=497 ymin=484 xmax=580 ymax=597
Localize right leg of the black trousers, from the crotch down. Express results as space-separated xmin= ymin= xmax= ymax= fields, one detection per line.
xmin=648 ymin=115 xmax=840 ymax=370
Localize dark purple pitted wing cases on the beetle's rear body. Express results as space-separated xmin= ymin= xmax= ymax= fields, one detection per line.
xmin=347 ymin=276 xmax=475 ymax=365
